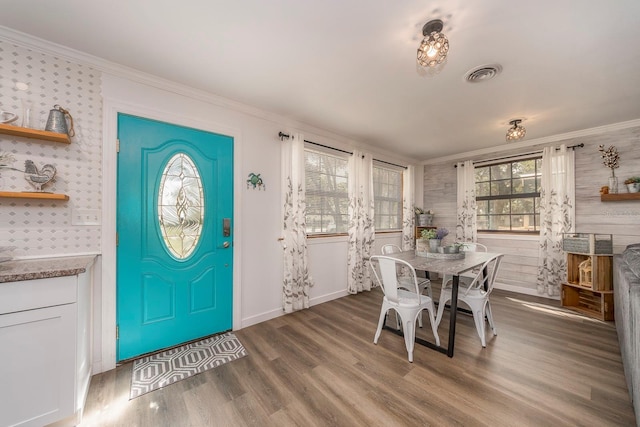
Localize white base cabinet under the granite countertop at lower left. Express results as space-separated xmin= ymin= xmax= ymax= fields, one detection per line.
xmin=0 ymin=260 xmax=92 ymax=426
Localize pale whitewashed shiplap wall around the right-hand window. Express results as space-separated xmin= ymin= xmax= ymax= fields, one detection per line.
xmin=423 ymin=123 xmax=640 ymax=294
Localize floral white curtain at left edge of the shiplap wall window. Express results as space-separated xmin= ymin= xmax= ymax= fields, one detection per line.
xmin=456 ymin=160 xmax=478 ymax=242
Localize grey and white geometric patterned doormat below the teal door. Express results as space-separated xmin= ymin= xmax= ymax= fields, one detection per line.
xmin=129 ymin=332 xmax=247 ymax=400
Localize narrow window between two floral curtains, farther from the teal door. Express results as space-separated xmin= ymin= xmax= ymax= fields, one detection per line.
xmin=373 ymin=163 xmax=402 ymax=231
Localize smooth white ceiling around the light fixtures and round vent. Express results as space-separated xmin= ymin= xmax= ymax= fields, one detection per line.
xmin=0 ymin=0 xmax=640 ymax=160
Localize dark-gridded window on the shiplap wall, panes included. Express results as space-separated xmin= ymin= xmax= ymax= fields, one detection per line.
xmin=475 ymin=157 xmax=542 ymax=232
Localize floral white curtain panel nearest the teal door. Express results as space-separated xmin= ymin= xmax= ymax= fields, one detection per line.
xmin=282 ymin=134 xmax=313 ymax=313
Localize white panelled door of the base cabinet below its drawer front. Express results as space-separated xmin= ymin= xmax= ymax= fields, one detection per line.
xmin=0 ymin=304 xmax=76 ymax=426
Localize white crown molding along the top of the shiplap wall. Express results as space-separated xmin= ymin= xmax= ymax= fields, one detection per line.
xmin=420 ymin=119 xmax=640 ymax=165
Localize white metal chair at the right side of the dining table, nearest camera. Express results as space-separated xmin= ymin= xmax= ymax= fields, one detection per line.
xmin=436 ymin=254 xmax=504 ymax=347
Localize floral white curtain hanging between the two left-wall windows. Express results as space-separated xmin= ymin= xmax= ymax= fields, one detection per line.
xmin=347 ymin=150 xmax=375 ymax=294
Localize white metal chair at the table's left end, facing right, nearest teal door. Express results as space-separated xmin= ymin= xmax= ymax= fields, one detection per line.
xmin=371 ymin=255 xmax=440 ymax=362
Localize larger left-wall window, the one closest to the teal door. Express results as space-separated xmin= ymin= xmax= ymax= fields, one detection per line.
xmin=304 ymin=148 xmax=349 ymax=234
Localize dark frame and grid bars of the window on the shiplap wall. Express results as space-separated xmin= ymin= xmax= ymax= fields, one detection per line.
xmin=474 ymin=154 xmax=542 ymax=235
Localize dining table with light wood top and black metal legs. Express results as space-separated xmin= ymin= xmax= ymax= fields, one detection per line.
xmin=385 ymin=251 xmax=499 ymax=357
